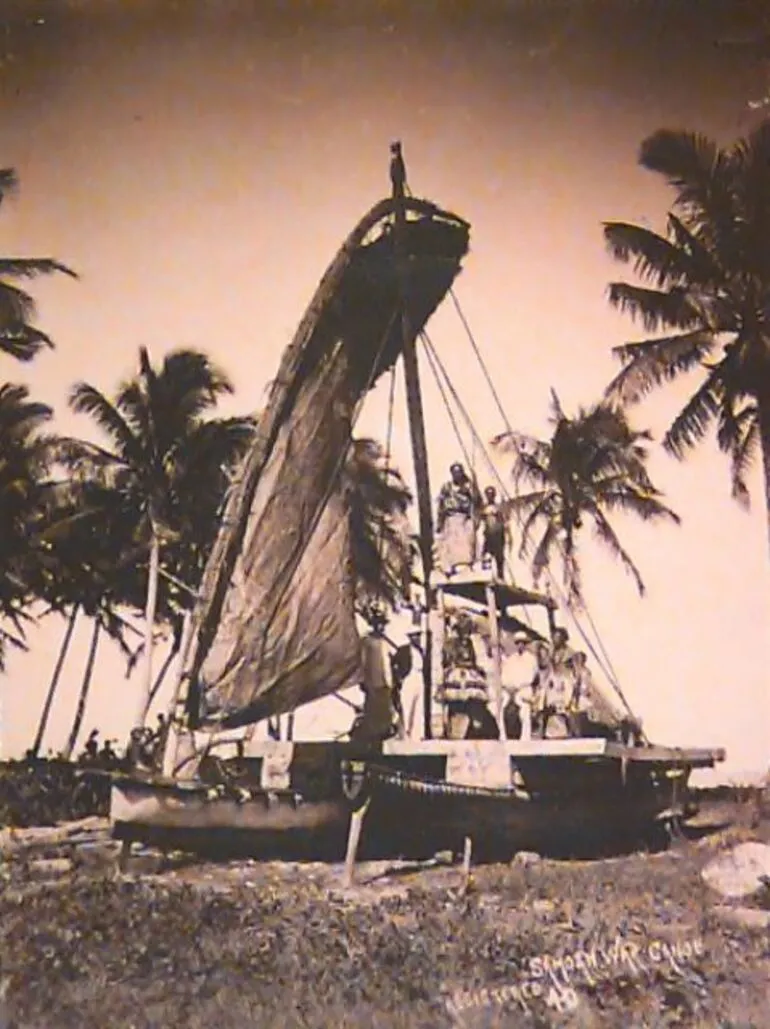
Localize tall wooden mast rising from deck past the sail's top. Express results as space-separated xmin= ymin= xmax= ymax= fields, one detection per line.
xmin=390 ymin=142 xmax=433 ymax=740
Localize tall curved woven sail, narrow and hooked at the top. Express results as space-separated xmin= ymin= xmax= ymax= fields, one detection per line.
xmin=184 ymin=198 xmax=469 ymax=728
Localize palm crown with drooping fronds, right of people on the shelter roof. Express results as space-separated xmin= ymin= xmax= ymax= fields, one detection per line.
xmin=493 ymin=391 xmax=679 ymax=606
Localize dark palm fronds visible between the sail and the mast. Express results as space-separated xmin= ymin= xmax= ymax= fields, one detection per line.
xmin=344 ymin=437 xmax=412 ymax=607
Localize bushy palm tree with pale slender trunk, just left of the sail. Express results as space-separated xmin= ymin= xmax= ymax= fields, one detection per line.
xmin=61 ymin=348 xmax=253 ymax=724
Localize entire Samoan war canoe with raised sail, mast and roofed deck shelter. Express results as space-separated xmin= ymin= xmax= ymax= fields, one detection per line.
xmin=105 ymin=143 xmax=725 ymax=865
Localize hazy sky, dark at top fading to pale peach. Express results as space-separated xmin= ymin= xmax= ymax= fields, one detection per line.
xmin=0 ymin=0 xmax=770 ymax=776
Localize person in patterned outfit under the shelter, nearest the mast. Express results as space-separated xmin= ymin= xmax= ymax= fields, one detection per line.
xmin=438 ymin=611 xmax=499 ymax=740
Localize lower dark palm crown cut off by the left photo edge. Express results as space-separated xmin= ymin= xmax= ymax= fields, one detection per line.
xmin=0 ymin=383 xmax=53 ymax=657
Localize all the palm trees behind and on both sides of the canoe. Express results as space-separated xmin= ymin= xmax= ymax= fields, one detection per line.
xmin=0 ymin=119 xmax=770 ymax=757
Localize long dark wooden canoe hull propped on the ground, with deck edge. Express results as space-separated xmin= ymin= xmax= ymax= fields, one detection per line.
xmin=110 ymin=740 xmax=719 ymax=859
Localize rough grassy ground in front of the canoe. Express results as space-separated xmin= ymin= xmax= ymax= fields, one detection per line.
xmin=0 ymin=802 xmax=770 ymax=1029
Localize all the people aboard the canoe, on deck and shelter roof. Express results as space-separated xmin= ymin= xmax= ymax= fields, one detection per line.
xmin=353 ymin=463 xmax=639 ymax=739
